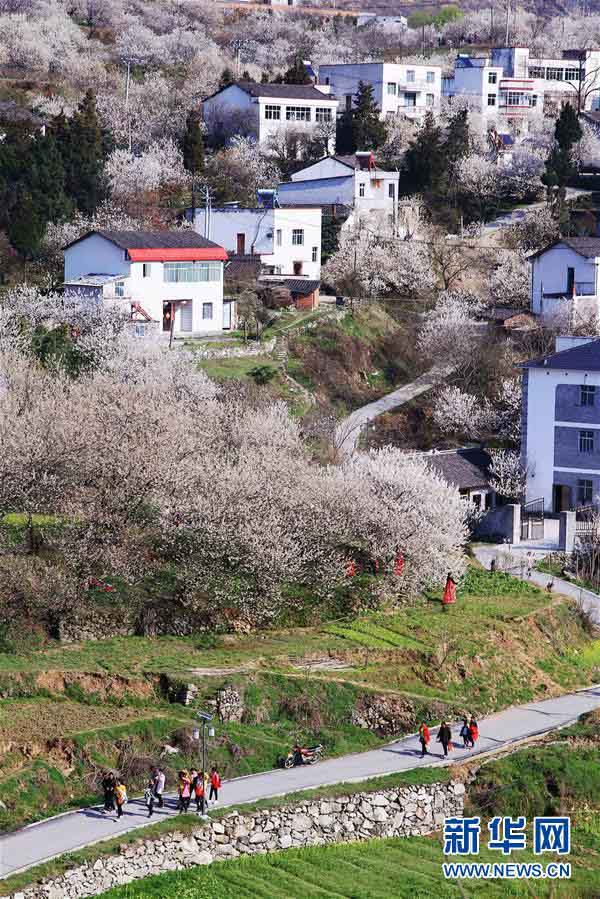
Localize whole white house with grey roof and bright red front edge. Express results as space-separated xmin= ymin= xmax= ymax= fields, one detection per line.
xmin=64 ymin=230 xmax=233 ymax=336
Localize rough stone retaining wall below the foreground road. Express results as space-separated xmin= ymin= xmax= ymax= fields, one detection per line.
xmin=12 ymin=783 xmax=465 ymax=899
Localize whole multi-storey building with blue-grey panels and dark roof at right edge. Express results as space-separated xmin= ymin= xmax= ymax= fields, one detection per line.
xmin=521 ymin=337 xmax=600 ymax=513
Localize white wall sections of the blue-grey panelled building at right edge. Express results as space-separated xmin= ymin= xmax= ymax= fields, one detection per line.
xmin=523 ymin=337 xmax=600 ymax=511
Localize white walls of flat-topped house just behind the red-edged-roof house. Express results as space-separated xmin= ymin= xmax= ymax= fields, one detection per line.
xmin=194 ymin=206 xmax=321 ymax=279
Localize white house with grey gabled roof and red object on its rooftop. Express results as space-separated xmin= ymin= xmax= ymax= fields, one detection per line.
xmin=277 ymin=151 xmax=399 ymax=220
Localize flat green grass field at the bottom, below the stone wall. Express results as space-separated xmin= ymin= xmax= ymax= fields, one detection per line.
xmin=103 ymin=837 xmax=600 ymax=899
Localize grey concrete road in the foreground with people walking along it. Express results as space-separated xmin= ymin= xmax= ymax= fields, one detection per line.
xmin=0 ymin=685 xmax=600 ymax=877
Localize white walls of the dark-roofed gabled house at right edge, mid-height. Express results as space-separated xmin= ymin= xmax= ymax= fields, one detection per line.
xmin=530 ymin=241 xmax=600 ymax=318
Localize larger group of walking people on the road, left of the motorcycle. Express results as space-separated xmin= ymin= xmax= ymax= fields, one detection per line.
xmin=102 ymin=765 xmax=222 ymax=820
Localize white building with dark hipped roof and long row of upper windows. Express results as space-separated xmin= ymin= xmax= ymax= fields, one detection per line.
xmin=202 ymin=81 xmax=338 ymax=152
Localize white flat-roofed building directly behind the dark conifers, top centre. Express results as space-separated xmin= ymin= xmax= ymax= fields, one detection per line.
xmin=319 ymin=62 xmax=442 ymax=119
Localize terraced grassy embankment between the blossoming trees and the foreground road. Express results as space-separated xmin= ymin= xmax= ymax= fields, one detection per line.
xmin=0 ymin=568 xmax=600 ymax=829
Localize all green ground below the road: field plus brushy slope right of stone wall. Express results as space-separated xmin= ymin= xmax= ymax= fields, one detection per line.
xmin=99 ymin=713 xmax=600 ymax=899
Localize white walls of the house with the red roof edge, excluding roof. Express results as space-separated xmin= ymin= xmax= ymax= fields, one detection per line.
xmin=65 ymin=234 xmax=227 ymax=336
